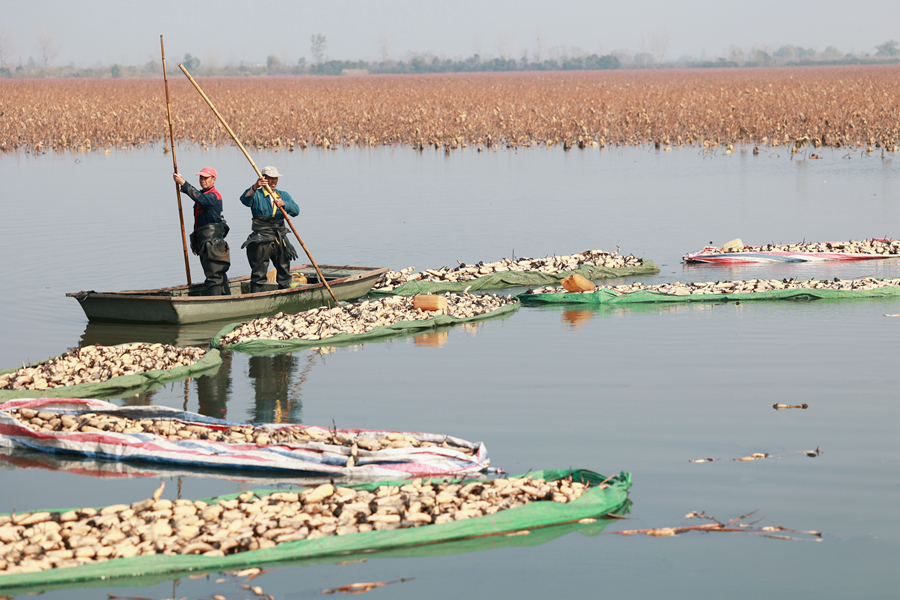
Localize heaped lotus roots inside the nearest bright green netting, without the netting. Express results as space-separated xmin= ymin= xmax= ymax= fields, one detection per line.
xmin=0 ymin=477 xmax=608 ymax=576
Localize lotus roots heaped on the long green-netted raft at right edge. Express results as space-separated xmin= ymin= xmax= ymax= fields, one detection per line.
xmin=532 ymin=277 xmax=900 ymax=296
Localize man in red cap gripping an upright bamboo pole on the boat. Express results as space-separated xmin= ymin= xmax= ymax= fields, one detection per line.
xmin=174 ymin=167 xmax=231 ymax=296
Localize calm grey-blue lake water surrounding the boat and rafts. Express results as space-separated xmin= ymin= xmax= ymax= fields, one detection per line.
xmin=0 ymin=147 xmax=900 ymax=599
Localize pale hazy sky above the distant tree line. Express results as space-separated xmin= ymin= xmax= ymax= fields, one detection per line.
xmin=0 ymin=0 xmax=900 ymax=67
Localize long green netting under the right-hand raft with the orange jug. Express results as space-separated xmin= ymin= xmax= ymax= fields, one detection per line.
xmin=516 ymin=286 xmax=900 ymax=305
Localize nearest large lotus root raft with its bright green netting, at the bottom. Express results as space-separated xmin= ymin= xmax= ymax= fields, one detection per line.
xmin=0 ymin=469 xmax=631 ymax=591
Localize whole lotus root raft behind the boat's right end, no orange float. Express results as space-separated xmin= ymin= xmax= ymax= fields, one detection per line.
xmin=369 ymin=250 xmax=659 ymax=296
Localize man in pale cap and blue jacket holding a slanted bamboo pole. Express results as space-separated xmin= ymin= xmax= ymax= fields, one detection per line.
xmin=241 ymin=167 xmax=300 ymax=293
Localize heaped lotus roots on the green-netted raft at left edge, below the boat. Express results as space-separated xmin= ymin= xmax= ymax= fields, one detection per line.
xmin=0 ymin=344 xmax=206 ymax=390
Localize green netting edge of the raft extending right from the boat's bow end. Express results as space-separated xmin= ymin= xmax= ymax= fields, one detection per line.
xmin=369 ymin=259 xmax=659 ymax=296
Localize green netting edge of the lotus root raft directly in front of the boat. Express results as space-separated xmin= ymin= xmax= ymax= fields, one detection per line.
xmin=210 ymin=302 xmax=520 ymax=354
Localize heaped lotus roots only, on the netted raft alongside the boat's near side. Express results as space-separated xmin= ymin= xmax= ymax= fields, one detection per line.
xmin=221 ymin=293 xmax=516 ymax=345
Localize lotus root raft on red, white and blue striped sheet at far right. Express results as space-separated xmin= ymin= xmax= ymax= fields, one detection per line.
xmin=682 ymin=238 xmax=900 ymax=265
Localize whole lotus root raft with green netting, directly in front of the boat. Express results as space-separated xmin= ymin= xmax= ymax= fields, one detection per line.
xmin=211 ymin=293 xmax=519 ymax=353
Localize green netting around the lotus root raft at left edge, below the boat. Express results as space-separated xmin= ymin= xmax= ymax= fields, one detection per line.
xmin=0 ymin=344 xmax=222 ymax=402
